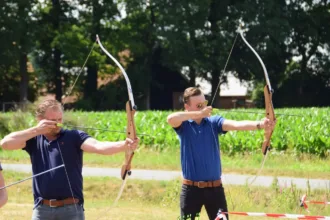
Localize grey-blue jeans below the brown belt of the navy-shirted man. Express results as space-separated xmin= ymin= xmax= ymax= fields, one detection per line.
xmin=32 ymin=204 xmax=85 ymax=220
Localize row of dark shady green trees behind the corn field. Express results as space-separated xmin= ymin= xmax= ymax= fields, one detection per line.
xmin=0 ymin=0 xmax=330 ymax=110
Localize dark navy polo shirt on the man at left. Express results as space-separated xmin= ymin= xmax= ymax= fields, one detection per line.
xmin=23 ymin=129 xmax=90 ymax=207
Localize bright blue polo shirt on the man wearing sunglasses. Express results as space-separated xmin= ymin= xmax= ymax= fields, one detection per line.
xmin=174 ymin=116 xmax=226 ymax=181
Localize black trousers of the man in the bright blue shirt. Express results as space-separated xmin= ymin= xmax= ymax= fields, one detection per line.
xmin=180 ymin=185 xmax=229 ymax=220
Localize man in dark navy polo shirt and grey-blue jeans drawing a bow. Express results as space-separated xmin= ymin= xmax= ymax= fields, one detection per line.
xmin=0 ymin=100 xmax=139 ymax=220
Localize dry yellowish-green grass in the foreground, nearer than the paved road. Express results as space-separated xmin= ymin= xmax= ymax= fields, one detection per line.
xmin=0 ymin=171 xmax=330 ymax=220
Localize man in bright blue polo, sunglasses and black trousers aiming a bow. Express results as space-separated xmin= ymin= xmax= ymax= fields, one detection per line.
xmin=167 ymin=87 xmax=275 ymax=220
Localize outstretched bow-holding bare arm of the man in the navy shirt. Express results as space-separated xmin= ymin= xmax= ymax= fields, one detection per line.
xmin=81 ymin=138 xmax=139 ymax=155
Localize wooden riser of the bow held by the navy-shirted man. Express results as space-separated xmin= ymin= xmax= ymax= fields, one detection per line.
xmin=121 ymin=101 xmax=137 ymax=180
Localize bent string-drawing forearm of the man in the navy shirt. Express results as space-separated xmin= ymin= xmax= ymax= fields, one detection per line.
xmin=0 ymin=127 xmax=39 ymax=150
